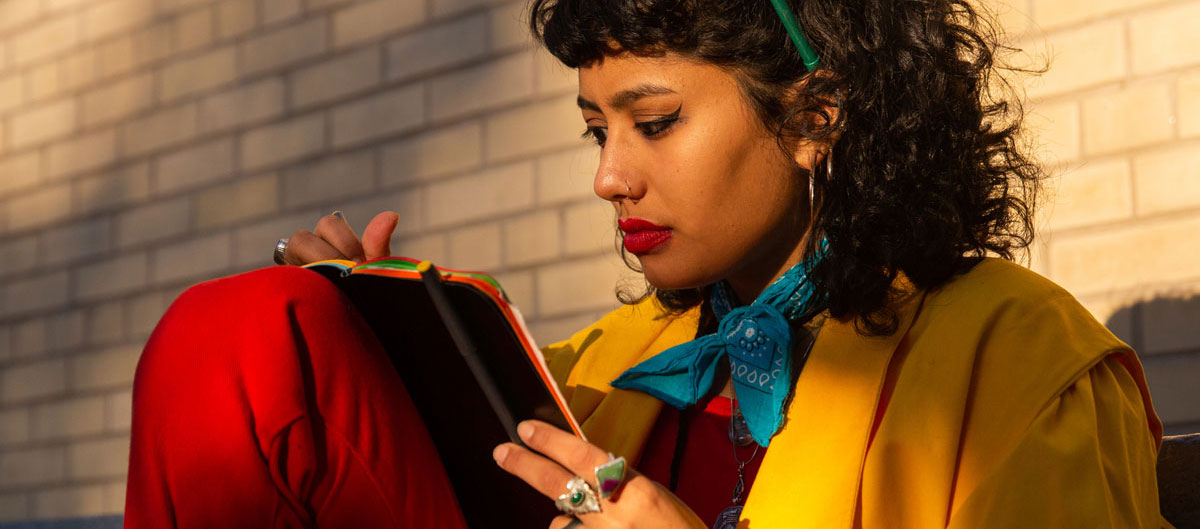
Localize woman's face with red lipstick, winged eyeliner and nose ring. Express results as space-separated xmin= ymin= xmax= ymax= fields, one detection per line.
xmin=580 ymin=54 xmax=814 ymax=302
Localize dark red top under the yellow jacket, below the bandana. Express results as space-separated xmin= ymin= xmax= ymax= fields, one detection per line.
xmin=638 ymin=397 xmax=767 ymax=527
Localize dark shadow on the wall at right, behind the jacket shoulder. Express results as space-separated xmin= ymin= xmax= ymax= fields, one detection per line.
xmin=1105 ymin=294 xmax=1200 ymax=435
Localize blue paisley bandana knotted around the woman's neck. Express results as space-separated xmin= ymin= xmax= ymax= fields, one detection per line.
xmin=612 ymin=245 xmax=826 ymax=446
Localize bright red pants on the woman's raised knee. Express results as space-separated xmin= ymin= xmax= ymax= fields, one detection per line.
xmin=125 ymin=266 xmax=466 ymax=529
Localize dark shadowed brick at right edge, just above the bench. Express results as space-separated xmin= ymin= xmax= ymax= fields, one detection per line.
xmin=1144 ymin=354 xmax=1200 ymax=423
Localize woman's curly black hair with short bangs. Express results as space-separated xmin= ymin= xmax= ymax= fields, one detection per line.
xmin=530 ymin=0 xmax=1043 ymax=335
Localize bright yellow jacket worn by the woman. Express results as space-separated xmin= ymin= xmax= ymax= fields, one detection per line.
xmin=547 ymin=259 xmax=1169 ymax=529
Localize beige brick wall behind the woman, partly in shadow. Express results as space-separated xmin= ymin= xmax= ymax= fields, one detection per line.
xmin=0 ymin=0 xmax=1200 ymax=521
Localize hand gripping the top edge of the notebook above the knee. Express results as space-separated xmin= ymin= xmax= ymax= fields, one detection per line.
xmin=283 ymin=211 xmax=400 ymax=265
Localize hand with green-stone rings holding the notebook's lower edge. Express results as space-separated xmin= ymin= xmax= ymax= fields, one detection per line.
xmin=492 ymin=421 xmax=704 ymax=529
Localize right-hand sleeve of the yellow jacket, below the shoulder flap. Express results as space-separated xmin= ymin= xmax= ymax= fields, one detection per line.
xmin=948 ymin=356 xmax=1171 ymax=529
